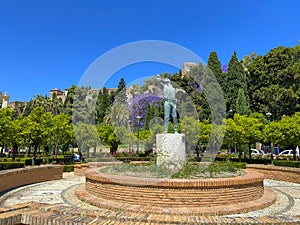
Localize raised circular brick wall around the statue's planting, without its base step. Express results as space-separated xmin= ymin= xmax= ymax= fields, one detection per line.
xmin=85 ymin=168 xmax=264 ymax=207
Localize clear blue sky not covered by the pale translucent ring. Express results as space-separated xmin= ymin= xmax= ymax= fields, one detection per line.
xmin=0 ymin=0 xmax=300 ymax=101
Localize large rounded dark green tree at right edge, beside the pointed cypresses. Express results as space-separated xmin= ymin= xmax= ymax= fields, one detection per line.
xmin=247 ymin=45 xmax=300 ymax=120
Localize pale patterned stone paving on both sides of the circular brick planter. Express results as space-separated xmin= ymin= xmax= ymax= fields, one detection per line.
xmin=0 ymin=172 xmax=300 ymax=223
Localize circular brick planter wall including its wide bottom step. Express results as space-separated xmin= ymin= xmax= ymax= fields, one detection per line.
xmin=76 ymin=167 xmax=276 ymax=215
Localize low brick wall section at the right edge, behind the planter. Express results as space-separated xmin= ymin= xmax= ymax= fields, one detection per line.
xmin=247 ymin=164 xmax=300 ymax=184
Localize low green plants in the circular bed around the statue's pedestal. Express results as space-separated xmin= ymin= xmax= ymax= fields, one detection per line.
xmin=100 ymin=162 xmax=245 ymax=179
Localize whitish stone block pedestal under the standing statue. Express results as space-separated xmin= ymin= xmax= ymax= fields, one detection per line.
xmin=156 ymin=134 xmax=186 ymax=170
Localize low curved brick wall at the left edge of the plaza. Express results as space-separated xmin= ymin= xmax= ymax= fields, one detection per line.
xmin=0 ymin=165 xmax=64 ymax=192
